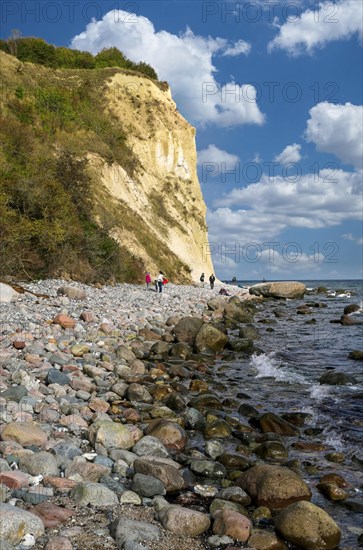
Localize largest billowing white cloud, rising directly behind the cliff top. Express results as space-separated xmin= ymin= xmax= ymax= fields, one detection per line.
xmin=71 ymin=10 xmax=264 ymax=127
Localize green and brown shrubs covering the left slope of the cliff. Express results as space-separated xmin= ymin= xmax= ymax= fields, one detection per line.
xmin=0 ymin=46 xmax=192 ymax=283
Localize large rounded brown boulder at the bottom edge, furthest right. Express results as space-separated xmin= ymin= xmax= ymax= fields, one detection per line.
xmin=275 ymin=502 xmax=341 ymax=550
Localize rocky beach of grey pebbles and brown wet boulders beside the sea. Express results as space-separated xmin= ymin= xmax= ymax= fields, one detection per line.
xmin=0 ymin=279 xmax=363 ymax=550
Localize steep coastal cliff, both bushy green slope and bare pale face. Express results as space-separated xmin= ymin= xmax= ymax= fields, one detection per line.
xmin=0 ymin=48 xmax=213 ymax=283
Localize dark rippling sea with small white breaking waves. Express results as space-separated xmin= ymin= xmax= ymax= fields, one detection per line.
xmin=216 ymin=280 xmax=363 ymax=550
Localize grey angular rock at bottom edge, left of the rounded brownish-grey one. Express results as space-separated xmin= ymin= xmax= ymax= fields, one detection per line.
xmin=110 ymin=516 xmax=161 ymax=548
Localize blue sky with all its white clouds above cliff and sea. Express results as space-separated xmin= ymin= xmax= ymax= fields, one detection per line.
xmin=1 ymin=0 xmax=363 ymax=281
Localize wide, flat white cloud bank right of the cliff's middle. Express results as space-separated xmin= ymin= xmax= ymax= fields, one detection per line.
xmin=209 ymin=170 xmax=362 ymax=240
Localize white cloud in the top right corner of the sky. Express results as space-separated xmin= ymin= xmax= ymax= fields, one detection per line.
xmin=268 ymin=0 xmax=363 ymax=56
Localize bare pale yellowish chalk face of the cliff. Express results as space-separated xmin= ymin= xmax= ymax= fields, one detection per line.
xmin=90 ymin=72 xmax=213 ymax=282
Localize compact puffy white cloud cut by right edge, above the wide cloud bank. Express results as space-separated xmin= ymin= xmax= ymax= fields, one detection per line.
xmin=306 ymin=102 xmax=363 ymax=168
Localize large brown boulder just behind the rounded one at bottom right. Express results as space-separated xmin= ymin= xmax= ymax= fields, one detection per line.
xmin=236 ymin=464 xmax=311 ymax=509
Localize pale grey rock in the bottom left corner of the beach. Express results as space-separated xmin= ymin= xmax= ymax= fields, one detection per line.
xmin=0 ymin=504 xmax=44 ymax=545
